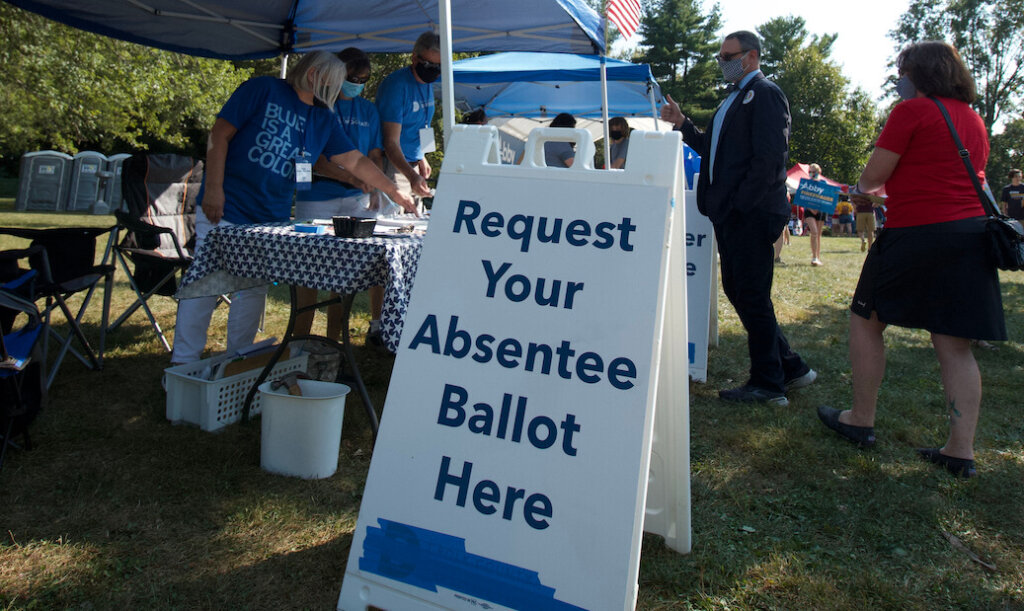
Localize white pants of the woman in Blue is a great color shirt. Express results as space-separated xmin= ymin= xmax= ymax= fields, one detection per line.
xmin=171 ymin=207 xmax=266 ymax=363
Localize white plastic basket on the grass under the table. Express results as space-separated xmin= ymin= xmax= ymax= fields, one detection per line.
xmin=164 ymin=354 xmax=308 ymax=431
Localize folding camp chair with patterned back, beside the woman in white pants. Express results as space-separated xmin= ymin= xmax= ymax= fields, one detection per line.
xmin=108 ymin=155 xmax=203 ymax=351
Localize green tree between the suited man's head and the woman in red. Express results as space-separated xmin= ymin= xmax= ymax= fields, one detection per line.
xmin=758 ymin=16 xmax=878 ymax=183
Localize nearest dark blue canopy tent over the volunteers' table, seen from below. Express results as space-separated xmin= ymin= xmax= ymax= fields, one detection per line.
xmin=4 ymin=0 xmax=605 ymax=133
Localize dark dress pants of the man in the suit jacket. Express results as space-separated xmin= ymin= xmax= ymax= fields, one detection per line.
xmin=715 ymin=210 xmax=808 ymax=392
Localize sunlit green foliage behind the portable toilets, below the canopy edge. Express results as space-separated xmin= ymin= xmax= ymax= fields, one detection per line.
xmin=0 ymin=3 xmax=253 ymax=169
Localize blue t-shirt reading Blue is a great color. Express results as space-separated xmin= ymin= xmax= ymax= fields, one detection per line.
xmin=200 ymin=77 xmax=355 ymax=224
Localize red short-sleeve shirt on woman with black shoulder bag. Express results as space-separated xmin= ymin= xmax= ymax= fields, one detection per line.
xmin=876 ymin=97 xmax=988 ymax=227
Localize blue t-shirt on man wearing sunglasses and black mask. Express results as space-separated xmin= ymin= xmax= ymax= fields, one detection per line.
xmin=377 ymin=68 xmax=434 ymax=163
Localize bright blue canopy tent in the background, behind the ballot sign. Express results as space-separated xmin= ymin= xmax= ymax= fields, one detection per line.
xmin=452 ymin=52 xmax=662 ymax=119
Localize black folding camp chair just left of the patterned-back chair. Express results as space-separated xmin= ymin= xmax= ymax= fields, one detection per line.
xmin=0 ymin=226 xmax=114 ymax=388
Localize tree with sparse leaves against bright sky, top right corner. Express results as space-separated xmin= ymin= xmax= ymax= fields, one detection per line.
xmin=889 ymin=0 xmax=1024 ymax=134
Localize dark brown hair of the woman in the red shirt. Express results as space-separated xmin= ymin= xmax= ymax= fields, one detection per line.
xmin=896 ymin=40 xmax=977 ymax=103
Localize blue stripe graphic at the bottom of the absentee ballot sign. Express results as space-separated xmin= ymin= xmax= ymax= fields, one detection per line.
xmin=359 ymin=518 xmax=582 ymax=611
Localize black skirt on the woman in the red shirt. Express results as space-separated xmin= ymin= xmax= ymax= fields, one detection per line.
xmin=850 ymin=217 xmax=1007 ymax=340
